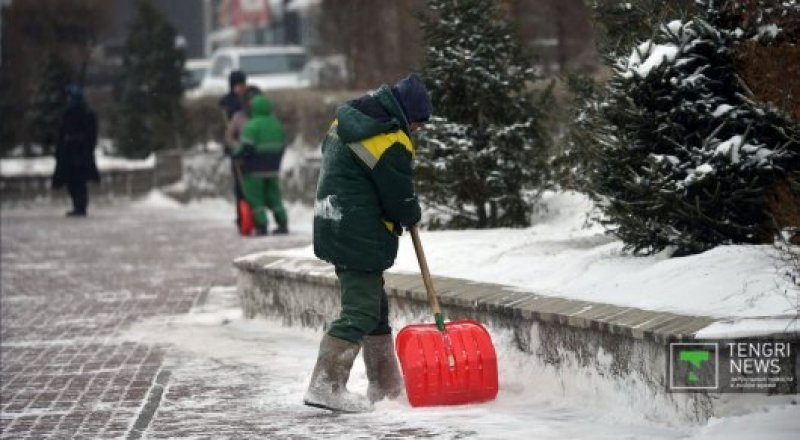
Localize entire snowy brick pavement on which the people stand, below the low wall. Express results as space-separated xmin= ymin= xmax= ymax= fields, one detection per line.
xmin=0 ymin=198 xmax=800 ymax=439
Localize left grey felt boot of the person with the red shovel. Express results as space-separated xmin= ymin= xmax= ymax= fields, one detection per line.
xmin=303 ymin=334 xmax=373 ymax=413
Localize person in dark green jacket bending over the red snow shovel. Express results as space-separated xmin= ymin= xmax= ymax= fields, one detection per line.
xmin=303 ymin=74 xmax=432 ymax=412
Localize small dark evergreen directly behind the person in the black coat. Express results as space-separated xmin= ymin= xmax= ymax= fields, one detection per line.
xmin=28 ymin=52 xmax=72 ymax=155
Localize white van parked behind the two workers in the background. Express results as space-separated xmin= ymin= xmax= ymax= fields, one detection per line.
xmin=190 ymin=46 xmax=310 ymax=97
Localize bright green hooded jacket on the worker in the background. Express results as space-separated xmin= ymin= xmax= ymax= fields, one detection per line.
xmin=233 ymin=95 xmax=286 ymax=175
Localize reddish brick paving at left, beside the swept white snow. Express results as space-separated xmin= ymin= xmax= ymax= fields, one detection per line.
xmin=0 ymin=196 xmax=308 ymax=438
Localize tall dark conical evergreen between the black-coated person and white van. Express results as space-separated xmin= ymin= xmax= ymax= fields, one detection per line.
xmin=113 ymin=0 xmax=186 ymax=157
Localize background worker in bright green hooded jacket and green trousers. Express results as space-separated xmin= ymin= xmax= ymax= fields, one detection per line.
xmin=232 ymin=94 xmax=289 ymax=235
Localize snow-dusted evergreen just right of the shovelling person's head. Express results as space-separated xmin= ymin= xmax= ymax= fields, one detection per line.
xmin=417 ymin=0 xmax=550 ymax=228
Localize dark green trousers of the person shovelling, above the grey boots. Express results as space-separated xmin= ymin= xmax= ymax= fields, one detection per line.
xmin=327 ymin=267 xmax=392 ymax=344
